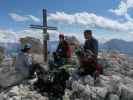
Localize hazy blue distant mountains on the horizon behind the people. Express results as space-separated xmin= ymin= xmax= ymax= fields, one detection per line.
xmin=0 ymin=39 xmax=133 ymax=56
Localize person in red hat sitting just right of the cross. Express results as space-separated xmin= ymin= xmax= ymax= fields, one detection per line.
xmin=53 ymin=34 xmax=71 ymax=66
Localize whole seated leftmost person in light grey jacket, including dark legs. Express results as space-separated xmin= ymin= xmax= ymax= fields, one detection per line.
xmin=15 ymin=43 xmax=40 ymax=80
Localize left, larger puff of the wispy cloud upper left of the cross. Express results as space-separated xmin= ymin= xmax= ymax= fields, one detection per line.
xmin=9 ymin=13 xmax=29 ymax=22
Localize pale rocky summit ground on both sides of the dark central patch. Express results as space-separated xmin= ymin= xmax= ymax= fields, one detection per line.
xmin=0 ymin=52 xmax=133 ymax=100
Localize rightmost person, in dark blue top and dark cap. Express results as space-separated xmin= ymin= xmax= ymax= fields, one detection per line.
xmin=77 ymin=30 xmax=98 ymax=76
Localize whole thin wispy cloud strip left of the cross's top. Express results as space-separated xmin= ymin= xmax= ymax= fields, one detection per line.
xmin=9 ymin=13 xmax=40 ymax=22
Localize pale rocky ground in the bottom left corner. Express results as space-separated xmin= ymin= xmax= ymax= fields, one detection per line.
xmin=0 ymin=84 xmax=48 ymax=100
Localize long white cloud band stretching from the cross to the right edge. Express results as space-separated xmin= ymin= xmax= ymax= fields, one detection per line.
xmin=48 ymin=12 xmax=133 ymax=31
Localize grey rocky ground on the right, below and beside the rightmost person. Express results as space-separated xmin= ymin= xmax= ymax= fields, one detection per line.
xmin=67 ymin=53 xmax=133 ymax=100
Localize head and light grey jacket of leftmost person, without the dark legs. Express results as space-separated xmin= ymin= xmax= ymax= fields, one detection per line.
xmin=15 ymin=43 xmax=32 ymax=78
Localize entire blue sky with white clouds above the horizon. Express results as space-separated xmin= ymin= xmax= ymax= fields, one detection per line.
xmin=0 ymin=0 xmax=133 ymax=42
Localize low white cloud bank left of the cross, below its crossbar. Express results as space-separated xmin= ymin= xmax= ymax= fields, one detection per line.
xmin=0 ymin=29 xmax=42 ymax=43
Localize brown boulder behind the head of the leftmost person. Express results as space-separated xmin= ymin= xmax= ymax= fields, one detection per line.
xmin=20 ymin=37 xmax=43 ymax=54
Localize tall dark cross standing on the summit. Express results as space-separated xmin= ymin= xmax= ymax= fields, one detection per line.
xmin=30 ymin=9 xmax=57 ymax=63
